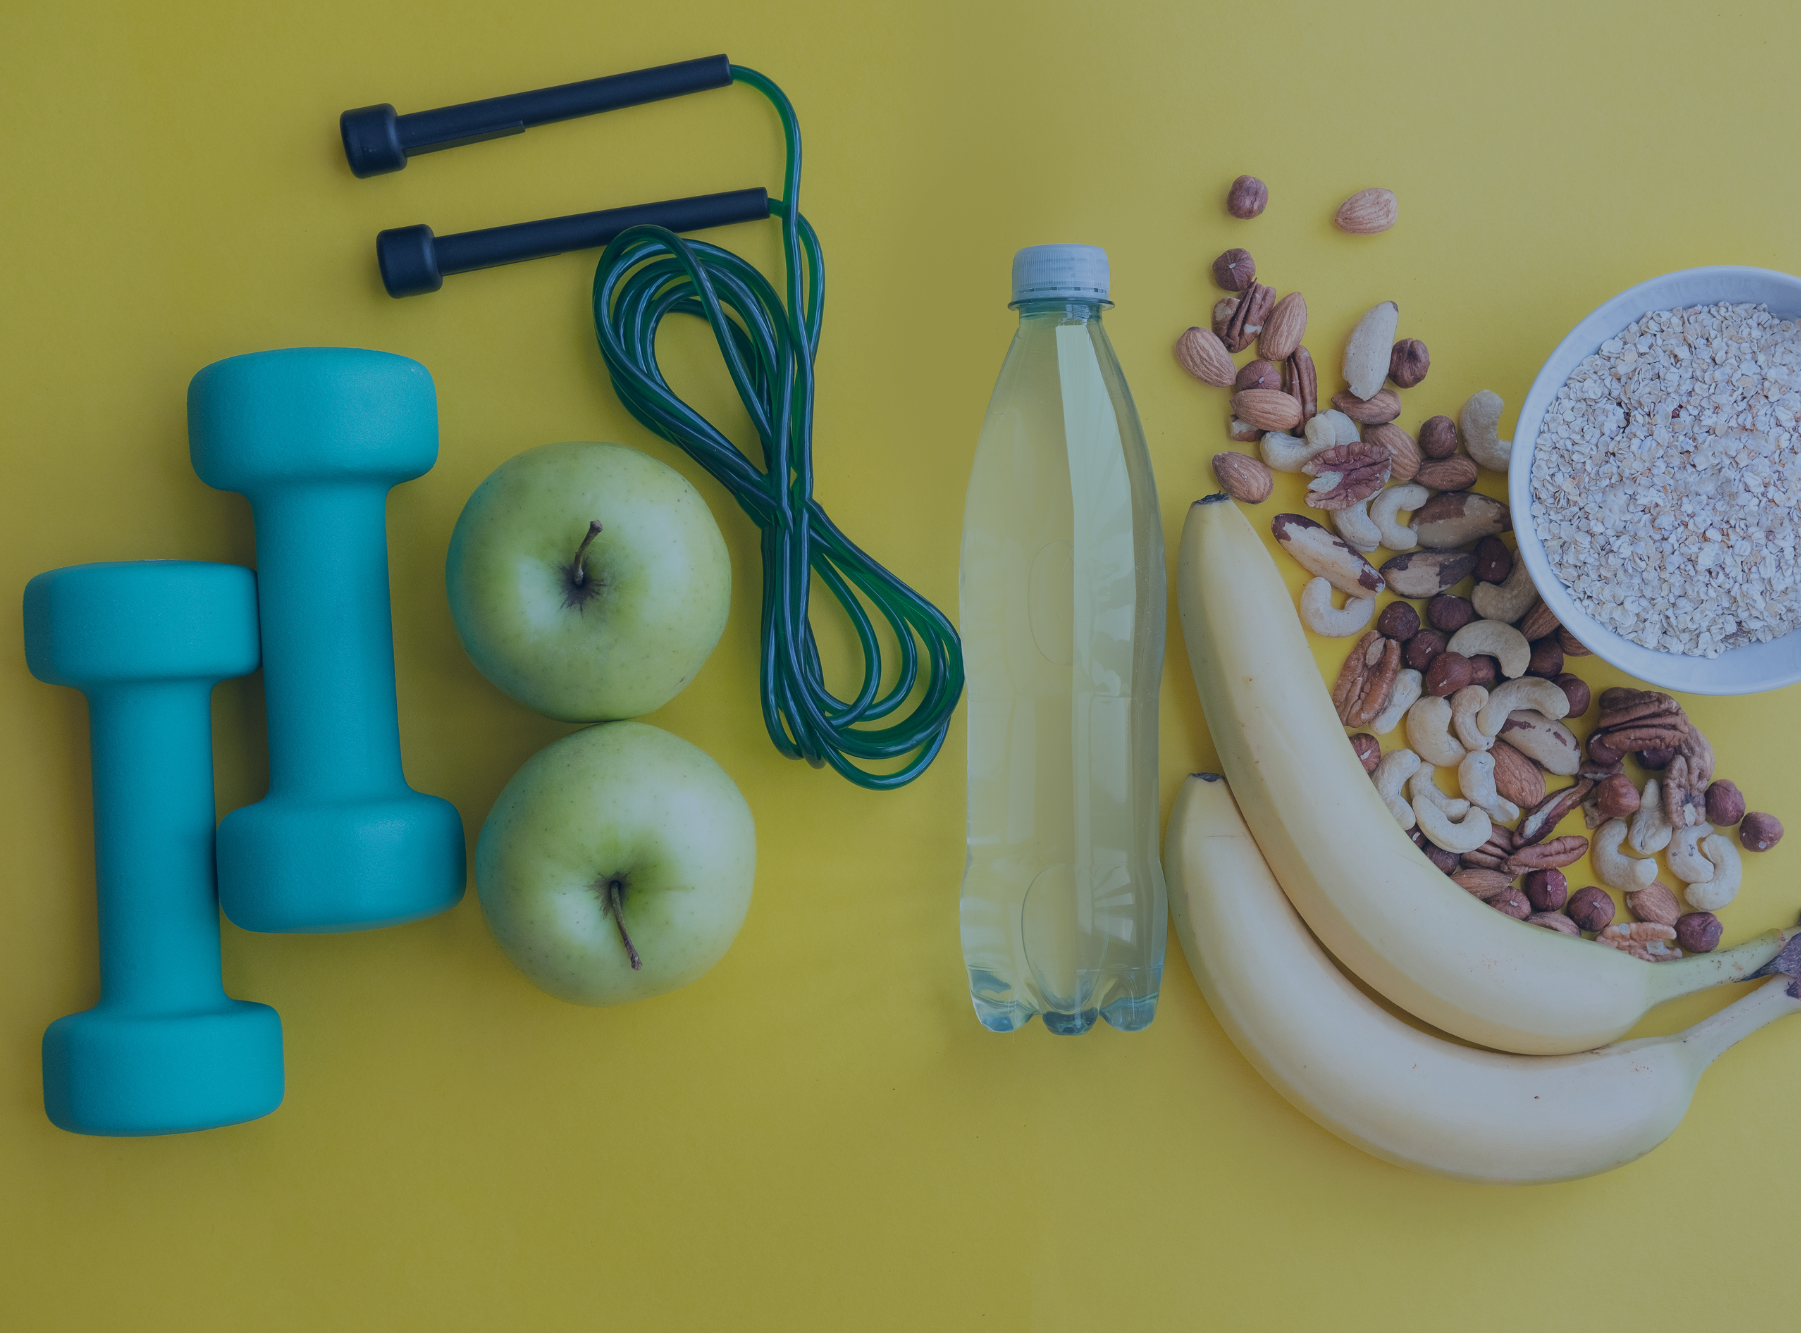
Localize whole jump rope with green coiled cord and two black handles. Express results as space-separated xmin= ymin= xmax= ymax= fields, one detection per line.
xmin=340 ymin=56 xmax=964 ymax=791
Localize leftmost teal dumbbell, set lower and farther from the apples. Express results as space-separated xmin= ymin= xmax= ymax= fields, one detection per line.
xmin=25 ymin=560 xmax=283 ymax=1135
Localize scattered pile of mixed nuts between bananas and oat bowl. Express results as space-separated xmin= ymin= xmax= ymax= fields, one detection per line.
xmin=1176 ymin=177 xmax=1783 ymax=962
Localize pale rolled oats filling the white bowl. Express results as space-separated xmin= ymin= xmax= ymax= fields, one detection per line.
xmin=1533 ymin=304 xmax=1801 ymax=657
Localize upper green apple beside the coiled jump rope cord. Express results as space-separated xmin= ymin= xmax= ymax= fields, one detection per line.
xmin=445 ymin=441 xmax=731 ymax=722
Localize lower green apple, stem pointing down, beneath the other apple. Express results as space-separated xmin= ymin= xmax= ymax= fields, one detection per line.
xmin=475 ymin=722 xmax=756 ymax=1005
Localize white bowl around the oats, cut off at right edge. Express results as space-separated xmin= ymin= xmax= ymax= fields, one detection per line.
xmin=1507 ymin=267 xmax=1801 ymax=694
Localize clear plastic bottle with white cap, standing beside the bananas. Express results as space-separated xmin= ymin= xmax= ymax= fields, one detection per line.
xmin=958 ymin=245 xmax=1167 ymax=1034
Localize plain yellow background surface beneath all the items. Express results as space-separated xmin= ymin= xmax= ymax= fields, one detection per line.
xmin=0 ymin=0 xmax=1801 ymax=1331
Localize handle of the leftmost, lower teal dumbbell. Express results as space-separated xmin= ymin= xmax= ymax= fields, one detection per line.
xmin=85 ymin=681 xmax=227 ymax=1014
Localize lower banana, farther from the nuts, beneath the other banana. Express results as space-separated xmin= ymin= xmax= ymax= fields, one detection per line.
xmin=1163 ymin=775 xmax=1801 ymax=1185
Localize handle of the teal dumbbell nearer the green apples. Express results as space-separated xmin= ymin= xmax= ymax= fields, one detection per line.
xmin=250 ymin=479 xmax=405 ymax=802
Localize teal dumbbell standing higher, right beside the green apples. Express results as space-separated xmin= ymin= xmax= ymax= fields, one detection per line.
xmin=187 ymin=348 xmax=463 ymax=931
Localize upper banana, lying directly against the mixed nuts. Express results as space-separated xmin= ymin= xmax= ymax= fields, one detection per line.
xmin=1176 ymin=495 xmax=1785 ymax=1056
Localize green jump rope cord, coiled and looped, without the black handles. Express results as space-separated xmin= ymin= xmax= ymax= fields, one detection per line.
xmin=594 ymin=65 xmax=964 ymax=791
